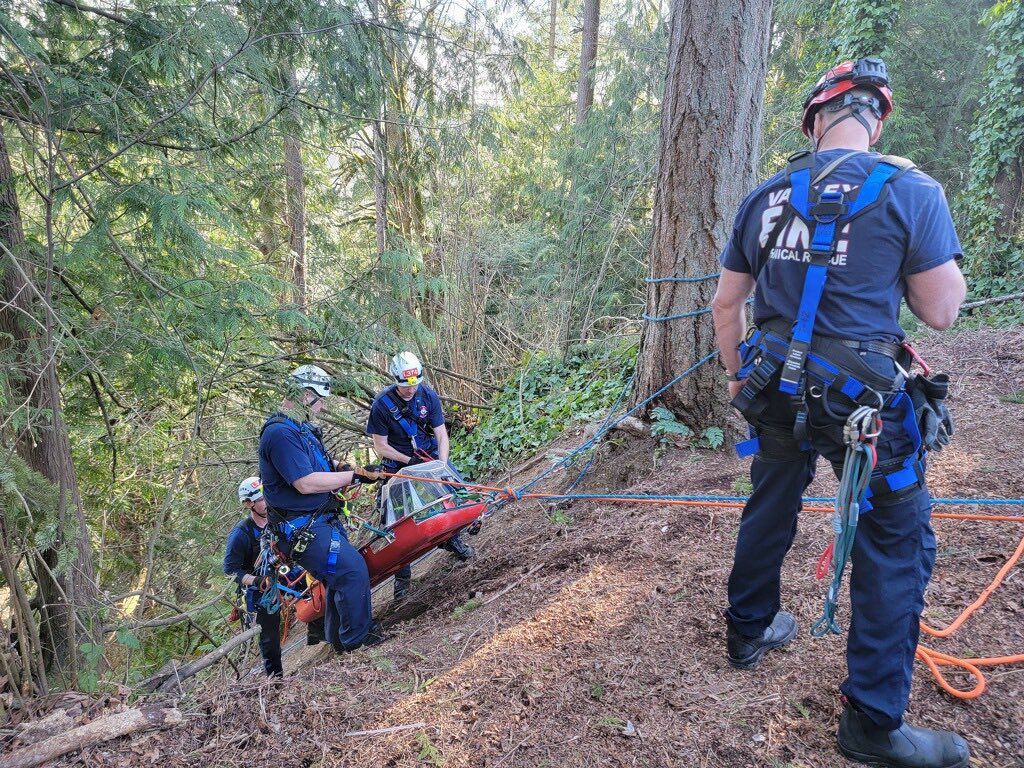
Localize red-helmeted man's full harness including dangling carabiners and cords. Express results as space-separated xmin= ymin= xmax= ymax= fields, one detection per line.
xmin=732 ymin=152 xmax=952 ymax=636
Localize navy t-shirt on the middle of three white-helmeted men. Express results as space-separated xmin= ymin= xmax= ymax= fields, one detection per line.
xmin=259 ymin=421 xmax=333 ymax=512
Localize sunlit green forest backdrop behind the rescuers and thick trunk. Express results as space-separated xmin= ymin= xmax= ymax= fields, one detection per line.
xmin=0 ymin=0 xmax=1024 ymax=697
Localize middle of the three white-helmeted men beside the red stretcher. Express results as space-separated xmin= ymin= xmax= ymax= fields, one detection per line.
xmin=259 ymin=366 xmax=384 ymax=652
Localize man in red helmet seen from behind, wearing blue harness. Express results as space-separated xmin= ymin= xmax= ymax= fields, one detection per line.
xmin=713 ymin=58 xmax=970 ymax=768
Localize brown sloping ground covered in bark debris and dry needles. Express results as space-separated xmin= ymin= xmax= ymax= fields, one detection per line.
xmin=8 ymin=331 xmax=1024 ymax=768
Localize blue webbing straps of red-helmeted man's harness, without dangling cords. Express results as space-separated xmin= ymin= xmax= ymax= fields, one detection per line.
xmin=732 ymin=153 xmax=926 ymax=511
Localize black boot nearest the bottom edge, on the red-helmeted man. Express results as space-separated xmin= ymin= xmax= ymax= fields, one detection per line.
xmin=839 ymin=703 xmax=971 ymax=768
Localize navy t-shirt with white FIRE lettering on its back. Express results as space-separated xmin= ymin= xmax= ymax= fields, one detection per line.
xmin=720 ymin=150 xmax=963 ymax=341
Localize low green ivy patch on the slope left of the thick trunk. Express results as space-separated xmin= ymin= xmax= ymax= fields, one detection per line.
xmin=452 ymin=345 xmax=636 ymax=478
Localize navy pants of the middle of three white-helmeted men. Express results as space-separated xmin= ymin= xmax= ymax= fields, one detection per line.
xmin=288 ymin=522 xmax=373 ymax=648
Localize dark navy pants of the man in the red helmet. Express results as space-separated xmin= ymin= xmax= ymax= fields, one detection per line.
xmin=726 ymin=353 xmax=935 ymax=730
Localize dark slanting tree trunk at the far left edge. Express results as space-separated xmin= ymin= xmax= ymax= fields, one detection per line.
xmin=0 ymin=131 xmax=98 ymax=685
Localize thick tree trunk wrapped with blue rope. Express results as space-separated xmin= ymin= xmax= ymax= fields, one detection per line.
xmin=633 ymin=0 xmax=772 ymax=430
